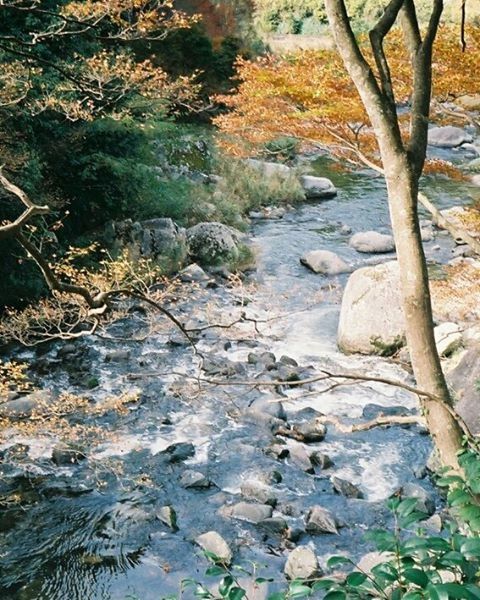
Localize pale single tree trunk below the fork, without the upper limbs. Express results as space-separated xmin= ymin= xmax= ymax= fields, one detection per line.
xmin=384 ymin=155 xmax=463 ymax=469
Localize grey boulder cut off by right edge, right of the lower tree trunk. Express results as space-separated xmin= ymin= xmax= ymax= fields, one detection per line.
xmin=447 ymin=343 xmax=480 ymax=435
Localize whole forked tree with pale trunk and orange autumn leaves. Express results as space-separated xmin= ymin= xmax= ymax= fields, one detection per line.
xmin=217 ymin=9 xmax=480 ymax=467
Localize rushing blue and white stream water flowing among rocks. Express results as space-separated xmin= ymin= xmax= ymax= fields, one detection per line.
xmin=0 ymin=148 xmax=480 ymax=600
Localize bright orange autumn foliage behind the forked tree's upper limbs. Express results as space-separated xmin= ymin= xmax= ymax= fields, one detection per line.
xmin=215 ymin=27 xmax=480 ymax=162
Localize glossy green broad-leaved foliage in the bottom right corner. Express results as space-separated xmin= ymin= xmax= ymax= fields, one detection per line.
xmin=167 ymin=450 xmax=480 ymax=600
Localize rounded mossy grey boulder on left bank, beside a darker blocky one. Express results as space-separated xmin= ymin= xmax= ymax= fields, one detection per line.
xmin=187 ymin=222 xmax=241 ymax=264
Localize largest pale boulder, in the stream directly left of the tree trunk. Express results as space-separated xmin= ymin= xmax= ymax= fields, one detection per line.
xmin=337 ymin=261 xmax=405 ymax=354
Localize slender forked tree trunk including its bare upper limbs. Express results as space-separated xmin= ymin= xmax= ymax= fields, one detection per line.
xmin=325 ymin=0 xmax=463 ymax=469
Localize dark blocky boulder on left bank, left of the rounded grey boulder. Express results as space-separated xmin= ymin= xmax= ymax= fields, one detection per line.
xmin=110 ymin=219 xmax=187 ymax=264
